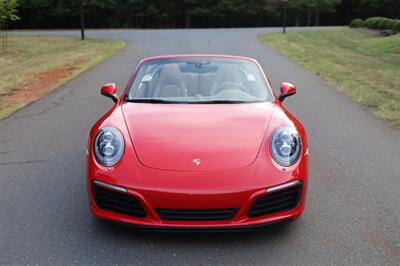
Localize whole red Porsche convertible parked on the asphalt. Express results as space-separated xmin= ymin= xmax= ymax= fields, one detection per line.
xmin=87 ymin=55 xmax=308 ymax=230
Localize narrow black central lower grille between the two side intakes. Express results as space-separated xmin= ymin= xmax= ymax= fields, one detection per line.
xmin=156 ymin=208 xmax=238 ymax=221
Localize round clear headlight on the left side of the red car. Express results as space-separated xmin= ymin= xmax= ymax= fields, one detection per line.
xmin=93 ymin=127 xmax=124 ymax=166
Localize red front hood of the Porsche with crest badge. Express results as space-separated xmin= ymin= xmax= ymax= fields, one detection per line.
xmin=121 ymin=102 xmax=274 ymax=171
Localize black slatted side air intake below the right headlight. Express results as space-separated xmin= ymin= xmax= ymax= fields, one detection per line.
xmin=247 ymin=183 xmax=301 ymax=217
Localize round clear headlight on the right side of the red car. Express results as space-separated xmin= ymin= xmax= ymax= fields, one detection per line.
xmin=270 ymin=126 xmax=301 ymax=166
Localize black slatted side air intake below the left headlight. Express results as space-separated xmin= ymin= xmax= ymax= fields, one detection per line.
xmin=93 ymin=184 xmax=146 ymax=217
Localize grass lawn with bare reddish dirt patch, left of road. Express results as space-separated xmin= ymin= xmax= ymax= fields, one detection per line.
xmin=0 ymin=35 xmax=124 ymax=119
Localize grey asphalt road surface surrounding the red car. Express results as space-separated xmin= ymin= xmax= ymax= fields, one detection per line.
xmin=0 ymin=29 xmax=400 ymax=265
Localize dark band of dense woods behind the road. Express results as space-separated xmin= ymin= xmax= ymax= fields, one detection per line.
xmin=10 ymin=0 xmax=400 ymax=29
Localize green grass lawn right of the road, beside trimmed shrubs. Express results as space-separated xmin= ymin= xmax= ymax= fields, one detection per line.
xmin=259 ymin=28 xmax=400 ymax=127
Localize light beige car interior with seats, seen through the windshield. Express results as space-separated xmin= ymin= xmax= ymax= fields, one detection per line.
xmin=129 ymin=62 xmax=266 ymax=99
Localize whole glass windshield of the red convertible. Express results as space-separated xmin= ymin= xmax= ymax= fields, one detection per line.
xmin=125 ymin=57 xmax=269 ymax=103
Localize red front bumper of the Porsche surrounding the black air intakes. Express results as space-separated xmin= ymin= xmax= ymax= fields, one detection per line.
xmin=88 ymin=179 xmax=306 ymax=231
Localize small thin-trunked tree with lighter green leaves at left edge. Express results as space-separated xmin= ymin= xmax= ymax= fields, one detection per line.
xmin=0 ymin=0 xmax=20 ymax=51
